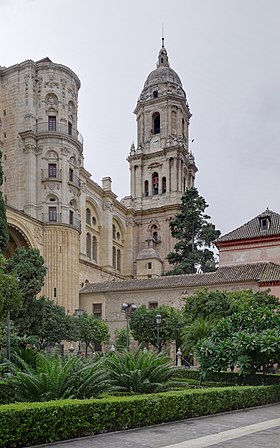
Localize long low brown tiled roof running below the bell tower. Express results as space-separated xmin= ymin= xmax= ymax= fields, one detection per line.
xmin=81 ymin=262 xmax=280 ymax=294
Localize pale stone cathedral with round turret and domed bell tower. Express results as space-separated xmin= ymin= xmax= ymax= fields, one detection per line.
xmin=0 ymin=41 xmax=197 ymax=313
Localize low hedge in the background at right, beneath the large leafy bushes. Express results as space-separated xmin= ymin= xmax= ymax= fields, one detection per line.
xmin=176 ymin=368 xmax=280 ymax=386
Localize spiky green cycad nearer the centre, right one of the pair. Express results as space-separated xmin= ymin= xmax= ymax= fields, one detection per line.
xmin=105 ymin=351 xmax=178 ymax=394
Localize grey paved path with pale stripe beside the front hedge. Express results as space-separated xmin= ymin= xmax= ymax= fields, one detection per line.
xmin=31 ymin=404 xmax=280 ymax=448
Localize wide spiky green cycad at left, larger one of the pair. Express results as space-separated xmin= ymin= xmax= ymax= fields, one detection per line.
xmin=11 ymin=353 xmax=108 ymax=401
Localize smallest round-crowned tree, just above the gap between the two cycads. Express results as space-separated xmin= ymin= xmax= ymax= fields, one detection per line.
xmin=78 ymin=313 xmax=109 ymax=355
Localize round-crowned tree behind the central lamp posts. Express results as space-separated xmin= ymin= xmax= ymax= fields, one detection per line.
xmin=130 ymin=305 xmax=183 ymax=351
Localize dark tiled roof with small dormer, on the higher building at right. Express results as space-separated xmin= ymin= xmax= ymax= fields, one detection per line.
xmin=216 ymin=209 xmax=280 ymax=246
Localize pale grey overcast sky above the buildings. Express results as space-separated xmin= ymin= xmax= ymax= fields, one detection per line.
xmin=0 ymin=0 xmax=280 ymax=234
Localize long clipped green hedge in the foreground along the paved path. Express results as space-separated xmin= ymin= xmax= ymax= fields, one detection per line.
xmin=0 ymin=386 xmax=280 ymax=448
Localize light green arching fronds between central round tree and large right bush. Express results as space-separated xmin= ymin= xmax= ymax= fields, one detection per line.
xmin=181 ymin=318 xmax=214 ymax=355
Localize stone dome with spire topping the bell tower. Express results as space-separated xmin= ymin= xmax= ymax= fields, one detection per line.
xmin=140 ymin=46 xmax=186 ymax=100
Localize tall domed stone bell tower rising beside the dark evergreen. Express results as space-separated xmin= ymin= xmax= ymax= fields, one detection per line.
xmin=125 ymin=39 xmax=197 ymax=277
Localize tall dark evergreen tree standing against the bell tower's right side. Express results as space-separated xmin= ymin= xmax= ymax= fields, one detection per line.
xmin=165 ymin=187 xmax=220 ymax=275
